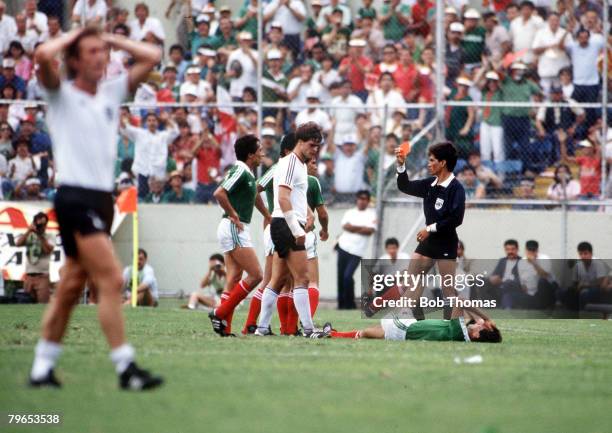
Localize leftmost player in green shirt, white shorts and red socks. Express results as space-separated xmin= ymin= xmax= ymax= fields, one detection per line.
xmin=209 ymin=135 xmax=270 ymax=337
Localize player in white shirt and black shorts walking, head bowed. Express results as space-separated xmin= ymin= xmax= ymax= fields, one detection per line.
xmin=255 ymin=122 xmax=329 ymax=338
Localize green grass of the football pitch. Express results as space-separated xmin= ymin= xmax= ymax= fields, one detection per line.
xmin=0 ymin=302 xmax=612 ymax=433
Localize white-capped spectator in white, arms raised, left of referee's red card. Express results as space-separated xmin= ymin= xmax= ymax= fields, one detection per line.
xmin=327 ymin=134 xmax=369 ymax=202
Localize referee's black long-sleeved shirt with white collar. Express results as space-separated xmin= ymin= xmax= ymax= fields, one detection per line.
xmin=397 ymin=167 xmax=465 ymax=240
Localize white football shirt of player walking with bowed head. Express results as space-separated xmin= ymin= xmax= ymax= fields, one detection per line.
xmin=272 ymin=152 xmax=308 ymax=224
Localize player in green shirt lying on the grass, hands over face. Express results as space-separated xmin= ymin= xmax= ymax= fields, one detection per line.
xmin=324 ymin=308 xmax=502 ymax=343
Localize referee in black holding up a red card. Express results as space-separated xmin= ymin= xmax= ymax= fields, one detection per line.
xmin=395 ymin=141 xmax=465 ymax=319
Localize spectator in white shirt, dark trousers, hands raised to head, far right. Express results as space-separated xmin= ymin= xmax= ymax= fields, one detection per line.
xmin=561 ymin=29 xmax=606 ymax=128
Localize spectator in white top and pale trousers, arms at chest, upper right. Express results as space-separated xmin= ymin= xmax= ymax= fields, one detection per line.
xmin=532 ymin=12 xmax=570 ymax=96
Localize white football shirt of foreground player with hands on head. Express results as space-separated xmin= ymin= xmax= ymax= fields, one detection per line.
xmin=45 ymin=74 xmax=128 ymax=192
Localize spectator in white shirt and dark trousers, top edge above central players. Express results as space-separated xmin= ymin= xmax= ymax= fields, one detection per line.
xmin=263 ymin=0 xmax=307 ymax=58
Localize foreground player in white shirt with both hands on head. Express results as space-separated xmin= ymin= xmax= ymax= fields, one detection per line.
xmin=30 ymin=28 xmax=162 ymax=390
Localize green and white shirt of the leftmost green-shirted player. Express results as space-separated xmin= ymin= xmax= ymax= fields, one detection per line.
xmin=221 ymin=161 xmax=257 ymax=224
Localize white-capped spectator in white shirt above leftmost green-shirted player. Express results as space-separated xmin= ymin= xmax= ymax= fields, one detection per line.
xmin=225 ymin=32 xmax=257 ymax=100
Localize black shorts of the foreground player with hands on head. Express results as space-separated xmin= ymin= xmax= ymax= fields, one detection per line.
xmin=54 ymin=186 xmax=115 ymax=258
